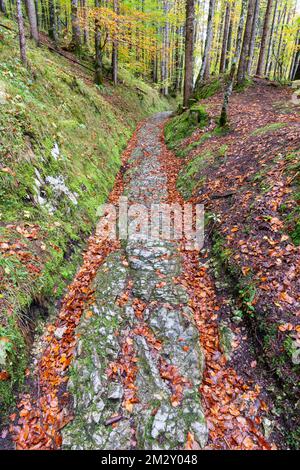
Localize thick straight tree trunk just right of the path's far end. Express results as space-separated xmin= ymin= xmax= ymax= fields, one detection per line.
xmin=183 ymin=0 xmax=195 ymax=108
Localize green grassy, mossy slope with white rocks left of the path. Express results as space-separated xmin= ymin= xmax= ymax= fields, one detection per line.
xmin=0 ymin=17 xmax=167 ymax=409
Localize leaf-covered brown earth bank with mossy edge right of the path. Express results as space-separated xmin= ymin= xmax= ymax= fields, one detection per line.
xmin=165 ymin=80 xmax=300 ymax=447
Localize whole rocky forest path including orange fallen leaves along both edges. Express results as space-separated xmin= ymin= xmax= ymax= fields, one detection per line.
xmin=12 ymin=113 xmax=270 ymax=450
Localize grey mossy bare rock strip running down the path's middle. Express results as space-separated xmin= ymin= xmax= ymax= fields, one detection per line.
xmin=63 ymin=114 xmax=208 ymax=450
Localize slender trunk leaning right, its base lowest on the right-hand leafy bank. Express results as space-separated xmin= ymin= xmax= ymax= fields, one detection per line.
xmin=220 ymin=0 xmax=247 ymax=127
